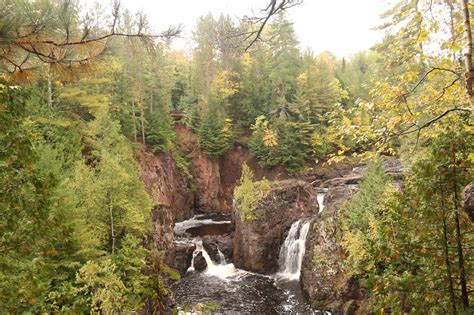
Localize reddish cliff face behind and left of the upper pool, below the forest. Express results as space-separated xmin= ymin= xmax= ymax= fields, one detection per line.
xmin=136 ymin=124 xmax=291 ymax=270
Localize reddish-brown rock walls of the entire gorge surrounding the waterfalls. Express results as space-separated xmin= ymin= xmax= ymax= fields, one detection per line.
xmin=137 ymin=124 xmax=402 ymax=314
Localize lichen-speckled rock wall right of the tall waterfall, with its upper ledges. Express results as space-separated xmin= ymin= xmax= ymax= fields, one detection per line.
xmin=301 ymin=158 xmax=403 ymax=314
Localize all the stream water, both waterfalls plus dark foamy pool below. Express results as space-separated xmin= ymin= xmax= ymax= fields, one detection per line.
xmin=171 ymin=216 xmax=329 ymax=314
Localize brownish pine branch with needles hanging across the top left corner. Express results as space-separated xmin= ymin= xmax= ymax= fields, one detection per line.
xmin=0 ymin=0 xmax=180 ymax=81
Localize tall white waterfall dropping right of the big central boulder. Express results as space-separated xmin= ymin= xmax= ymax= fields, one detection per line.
xmin=278 ymin=220 xmax=310 ymax=279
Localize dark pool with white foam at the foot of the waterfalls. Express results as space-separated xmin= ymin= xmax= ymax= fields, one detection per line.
xmin=172 ymin=264 xmax=324 ymax=314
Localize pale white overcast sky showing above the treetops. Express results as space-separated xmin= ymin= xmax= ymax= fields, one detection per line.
xmin=85 ymin=0 xmax=387 ymax=57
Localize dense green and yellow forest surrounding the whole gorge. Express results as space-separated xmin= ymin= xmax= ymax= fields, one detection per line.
xmin=0 ymin=0 xmax=474 ymax=314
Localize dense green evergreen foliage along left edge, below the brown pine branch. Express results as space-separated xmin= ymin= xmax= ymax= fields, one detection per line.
xmin=0 ymin=84 xmax=81 ymax=313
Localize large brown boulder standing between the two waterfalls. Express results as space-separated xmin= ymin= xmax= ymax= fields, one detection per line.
xmin=233 ymin=180 xmax=318 ymax=274
